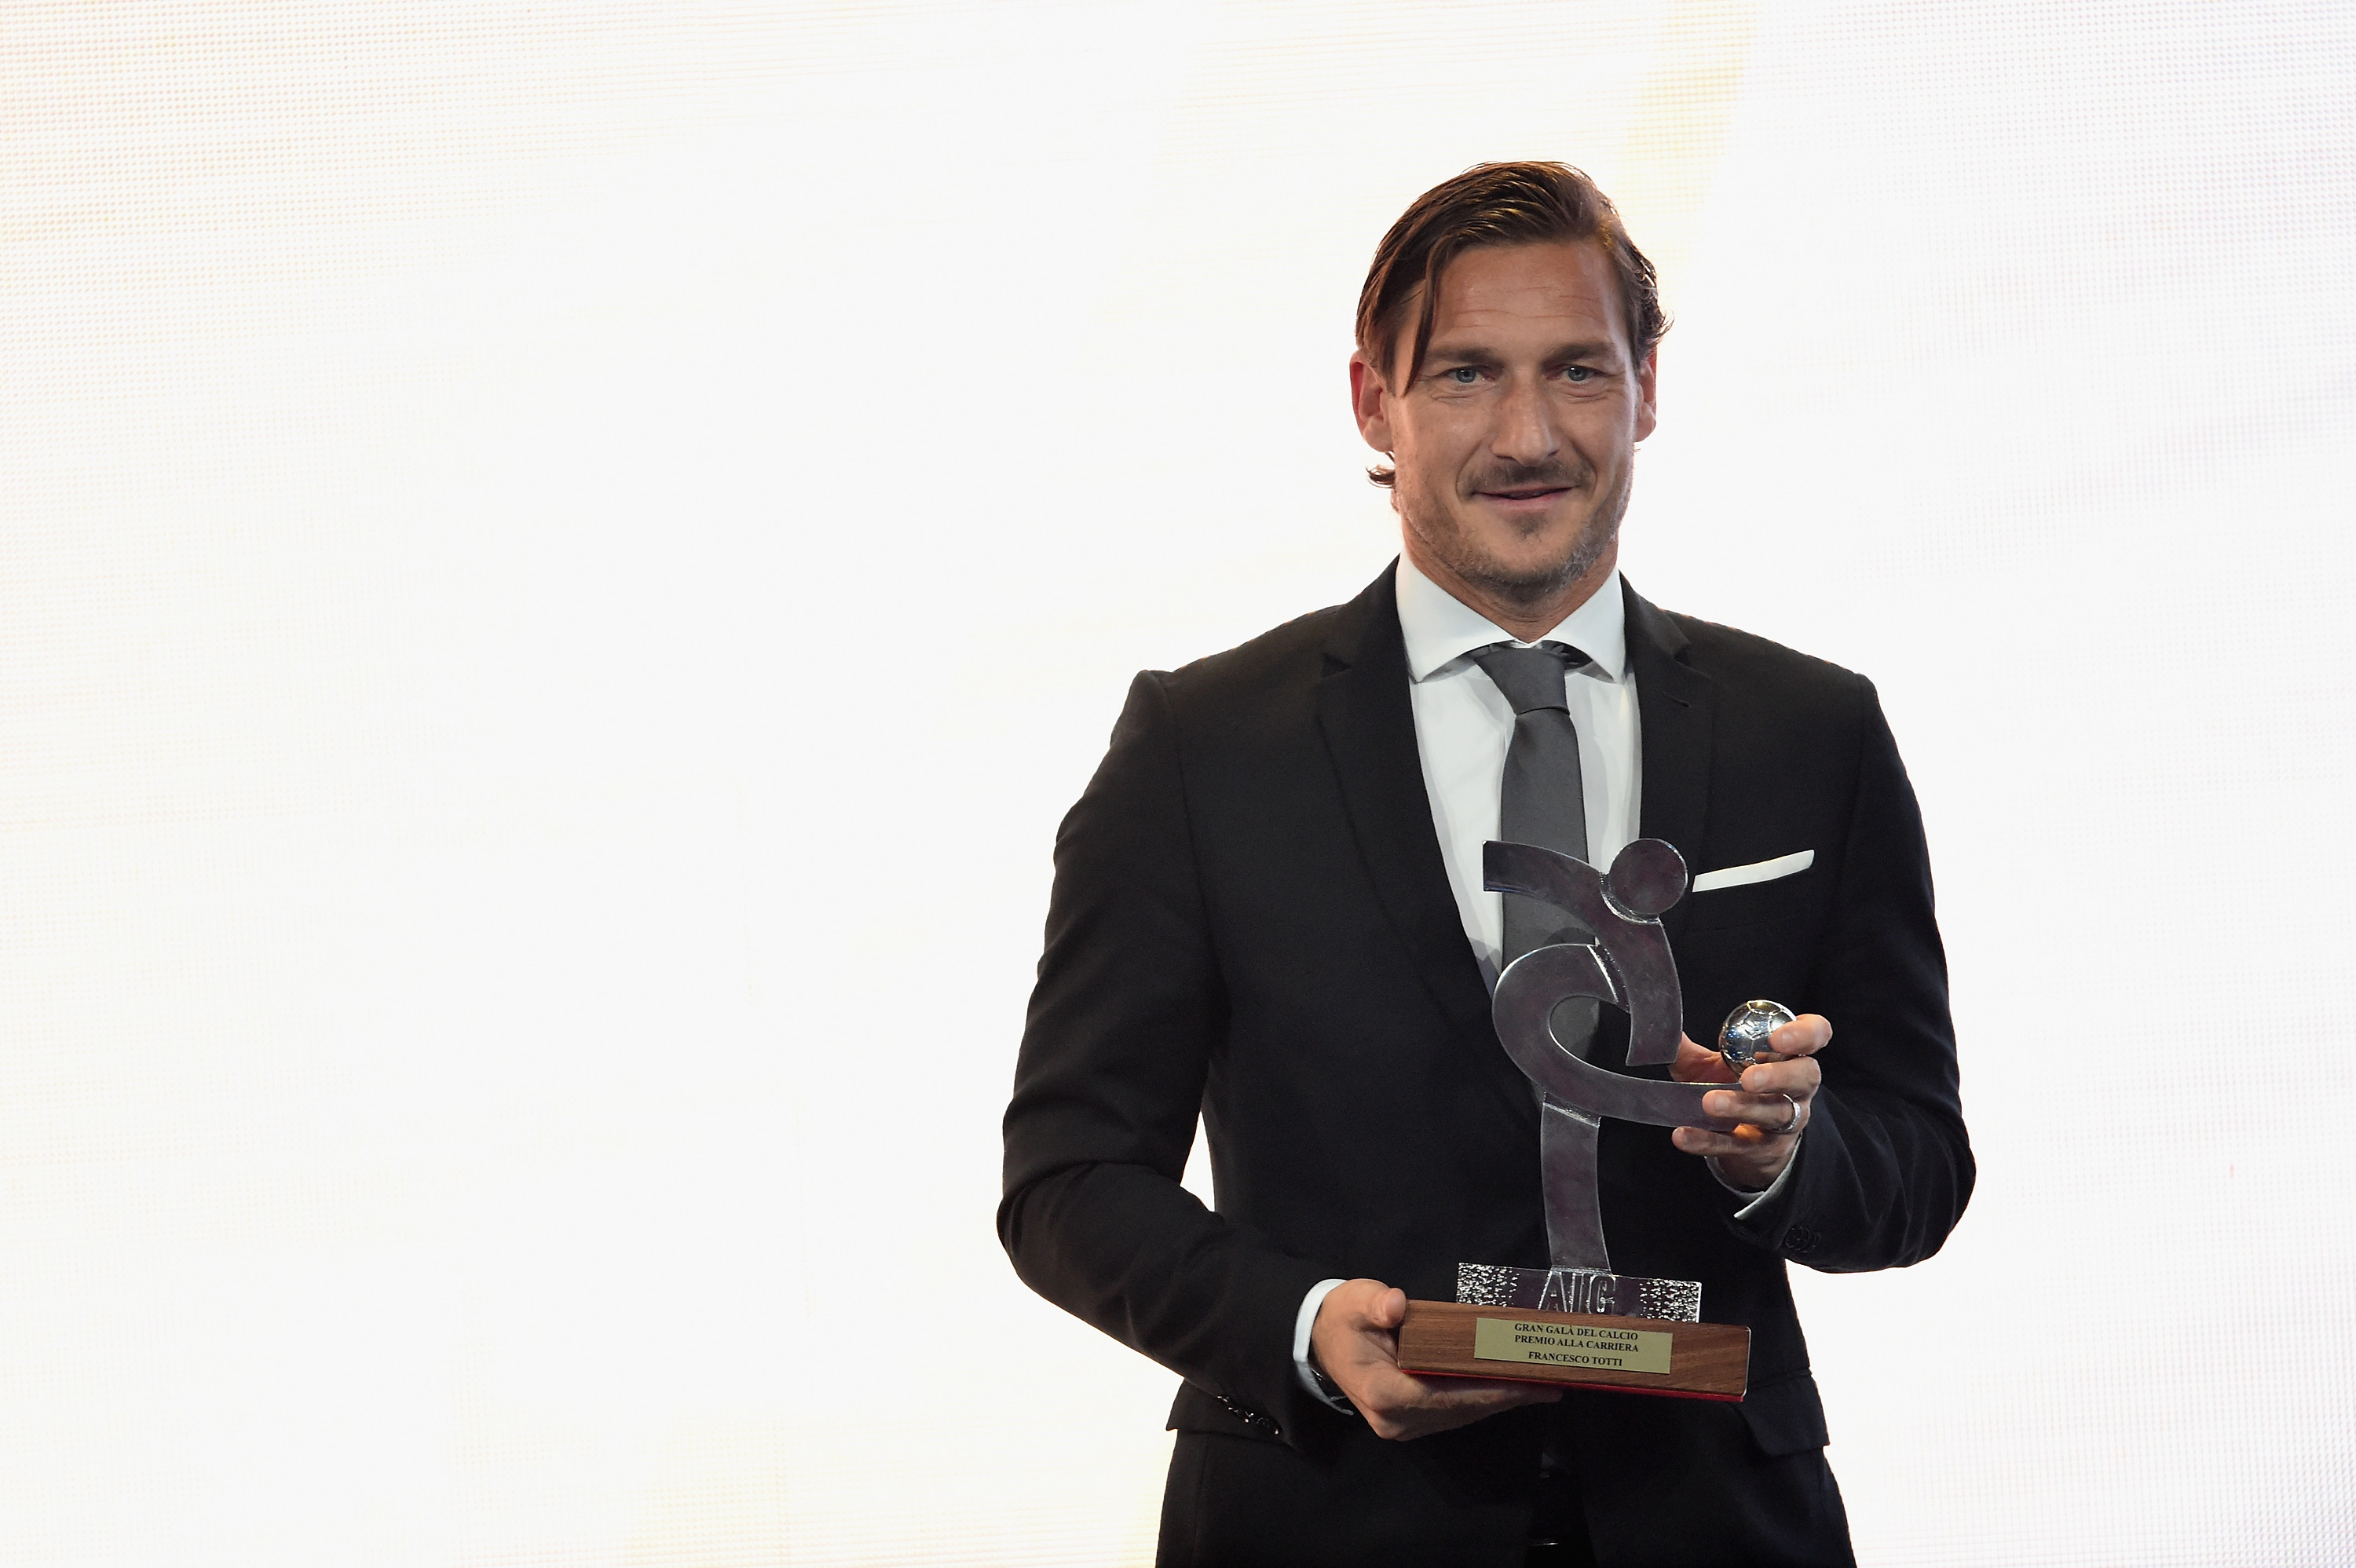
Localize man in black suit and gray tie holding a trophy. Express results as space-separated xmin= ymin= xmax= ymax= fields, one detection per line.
xmin=999 ymin=163 xmax=1972 ymax=1568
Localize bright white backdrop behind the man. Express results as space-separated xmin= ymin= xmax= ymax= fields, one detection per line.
xmin=0 ymin=0 xmax=2356 ymax=1568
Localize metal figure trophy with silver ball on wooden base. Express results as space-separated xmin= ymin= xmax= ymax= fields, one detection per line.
xmin=1399 ymin=838 xmax=1793 ymax=1401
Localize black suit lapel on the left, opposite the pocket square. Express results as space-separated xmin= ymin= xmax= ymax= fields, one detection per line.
xmin=1317 ymin=565 xmax=1489 ymax=1026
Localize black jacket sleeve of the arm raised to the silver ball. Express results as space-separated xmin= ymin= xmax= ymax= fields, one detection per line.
xmin=1732 ymin=678 xmax=1974 ymax=1274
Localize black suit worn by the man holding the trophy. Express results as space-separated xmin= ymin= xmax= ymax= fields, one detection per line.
xmin=999 ymin=572 xmax=1972 ymax=1563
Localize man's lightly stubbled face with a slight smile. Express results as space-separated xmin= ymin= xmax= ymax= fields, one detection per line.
xmin=1350 ymin=240 xmax=1654 ymax=603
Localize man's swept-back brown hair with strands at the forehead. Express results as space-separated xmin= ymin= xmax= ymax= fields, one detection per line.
xmin=1357 ymin=163 xmax=1668 ymax=485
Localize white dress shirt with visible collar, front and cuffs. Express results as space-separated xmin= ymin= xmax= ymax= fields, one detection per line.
xmin=1293 ymin=556 xmax=1791 ymax=1410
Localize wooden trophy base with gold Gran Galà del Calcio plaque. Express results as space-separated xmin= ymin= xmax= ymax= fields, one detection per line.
xmin=1399 ymin=1302 xmax=1751 ymax=1401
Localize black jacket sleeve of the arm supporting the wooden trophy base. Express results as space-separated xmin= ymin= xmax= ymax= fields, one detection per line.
xmin=999 ymin=671 xmax=1329 ymax=1438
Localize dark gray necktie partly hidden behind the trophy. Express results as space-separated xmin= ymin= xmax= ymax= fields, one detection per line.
xmin=1472 ymin=643 xmax=1597 ymax=1057
